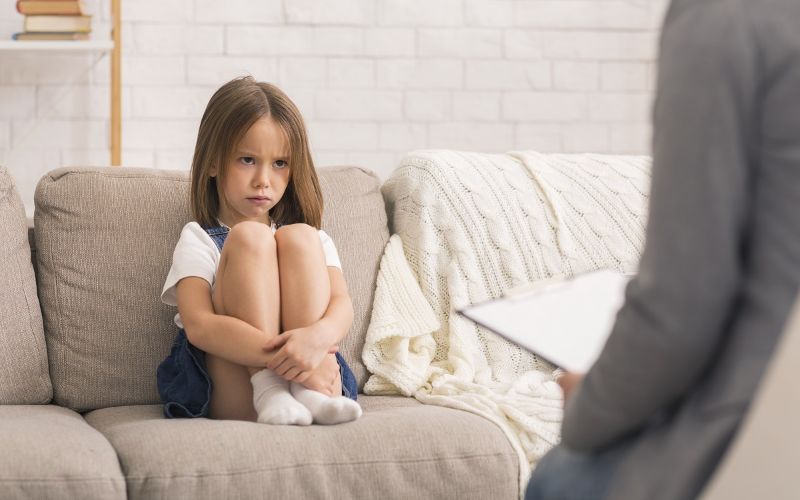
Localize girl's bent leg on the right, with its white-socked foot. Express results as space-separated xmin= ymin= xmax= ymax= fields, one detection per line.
xmin=275 ymin=224 xmax=361 ymax=424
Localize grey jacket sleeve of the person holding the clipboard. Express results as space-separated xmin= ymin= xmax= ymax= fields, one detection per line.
xmin=562 ymin=0 xmax=758 ymax=450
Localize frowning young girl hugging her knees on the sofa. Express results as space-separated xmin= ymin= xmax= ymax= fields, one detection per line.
xmin=158 ymin=77 xmax=361 ymax=425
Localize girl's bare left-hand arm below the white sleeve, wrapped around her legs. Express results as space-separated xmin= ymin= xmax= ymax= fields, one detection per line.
xmin=177 ymin=276 xmax=282 ymax=368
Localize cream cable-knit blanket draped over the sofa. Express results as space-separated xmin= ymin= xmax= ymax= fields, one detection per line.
xmin=363 ymin=151 xmax=650 ymax=491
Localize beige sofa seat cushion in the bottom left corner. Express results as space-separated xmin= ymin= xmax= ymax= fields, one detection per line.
xmin=0 ymin=405 xmax=125 ymax=499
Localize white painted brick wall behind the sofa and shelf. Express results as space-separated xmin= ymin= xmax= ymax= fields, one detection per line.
xmin=0 ymin=0 xmax=667 ymax=213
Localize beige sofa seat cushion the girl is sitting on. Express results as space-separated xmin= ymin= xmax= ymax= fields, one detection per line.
xmin=86 ymin=396 xmax=519 ymax=499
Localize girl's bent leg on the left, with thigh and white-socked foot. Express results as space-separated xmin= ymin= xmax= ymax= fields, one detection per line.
xmin=206 ymin=222 xmax=310 ymax=424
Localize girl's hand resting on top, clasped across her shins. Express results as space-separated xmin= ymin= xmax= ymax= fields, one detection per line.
xmin=264 ymin=325 xmax=338 ymax=384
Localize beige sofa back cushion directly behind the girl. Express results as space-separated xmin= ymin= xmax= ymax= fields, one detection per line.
xmin=34 ymin=167 xmax=388 ymax=411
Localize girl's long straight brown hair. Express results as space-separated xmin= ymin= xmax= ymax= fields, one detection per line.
xmin=190 ymin=76 xmax=322 ymax=229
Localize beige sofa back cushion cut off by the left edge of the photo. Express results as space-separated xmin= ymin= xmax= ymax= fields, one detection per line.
xmin=0 ymin=167 xmax=53 ymax=404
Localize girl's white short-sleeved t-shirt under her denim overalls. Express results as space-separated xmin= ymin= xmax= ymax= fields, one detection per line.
xmin=161 ymin=222 xmax=342 ymax=328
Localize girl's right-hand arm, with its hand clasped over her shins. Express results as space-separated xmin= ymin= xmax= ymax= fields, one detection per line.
xmin=264 ymin=266 xmax=353 ymax=383
